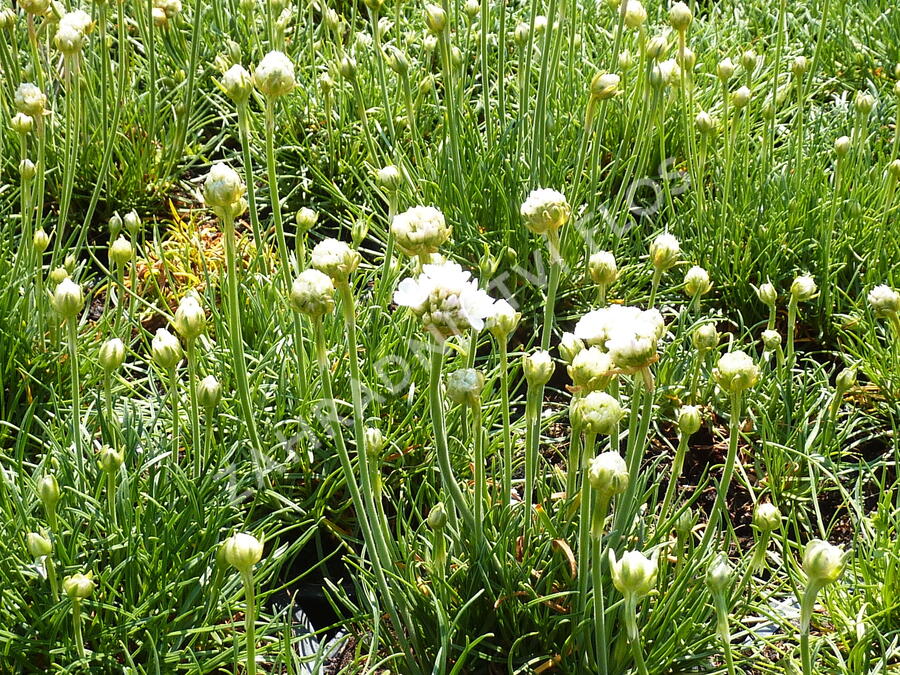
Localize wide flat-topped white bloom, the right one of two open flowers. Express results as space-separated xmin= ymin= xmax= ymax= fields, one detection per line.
xmin=575 ymin=305 xmax=665 ymax=372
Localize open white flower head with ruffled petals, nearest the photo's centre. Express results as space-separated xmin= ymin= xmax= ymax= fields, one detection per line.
xmin=394 ymin=262 xmax=494 ymax=341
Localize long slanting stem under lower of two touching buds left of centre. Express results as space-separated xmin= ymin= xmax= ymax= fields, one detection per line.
xmin=313 ymin=318 xmax=418 ymax=673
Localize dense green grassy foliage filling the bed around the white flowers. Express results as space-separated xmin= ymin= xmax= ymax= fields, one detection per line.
xmin=0 ymin=0 xmax=900 ymax=674
